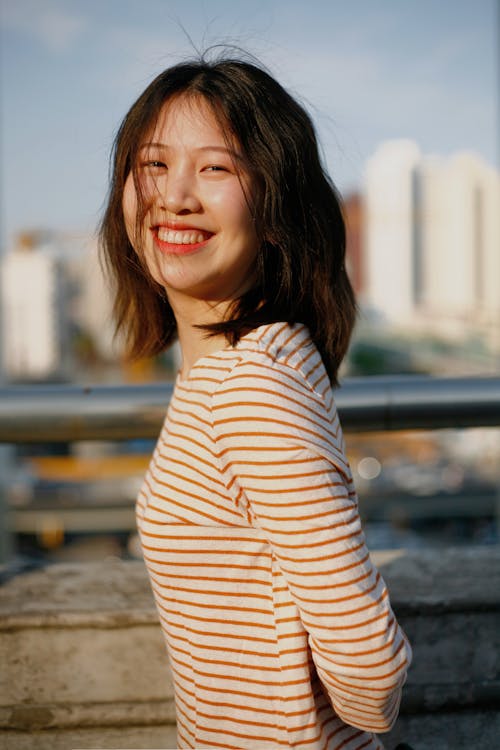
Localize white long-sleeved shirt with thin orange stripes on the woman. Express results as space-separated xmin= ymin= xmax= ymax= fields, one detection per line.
xmin=137 ymin=323 xmax=411 ymax=750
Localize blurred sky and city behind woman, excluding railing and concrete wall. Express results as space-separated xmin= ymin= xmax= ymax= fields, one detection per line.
xmin=0 ymin=0 xmax=500 ymax=565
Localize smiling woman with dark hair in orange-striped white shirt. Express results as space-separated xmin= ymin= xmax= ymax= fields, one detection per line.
xmin=101 ymin=54 xmax=411 ymax=750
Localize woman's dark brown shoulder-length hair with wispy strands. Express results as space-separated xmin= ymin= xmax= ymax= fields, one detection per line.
xmin=100 ymin=53 xmax=356 ymax=385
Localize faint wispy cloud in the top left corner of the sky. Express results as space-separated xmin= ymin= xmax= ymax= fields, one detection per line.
xmin=1 ymin=0 xmax=88 ymax=54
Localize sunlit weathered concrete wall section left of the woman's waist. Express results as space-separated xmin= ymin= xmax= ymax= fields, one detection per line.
xmin=0 ymin=561 xmax=174 ymax=729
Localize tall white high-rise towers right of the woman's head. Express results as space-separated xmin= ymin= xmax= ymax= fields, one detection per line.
xmin=365 ymin=141 xmax=500 ymax=347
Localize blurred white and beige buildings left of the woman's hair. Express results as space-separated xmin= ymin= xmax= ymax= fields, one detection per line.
xmin=0 ymin=231 xmax=118 ymax=382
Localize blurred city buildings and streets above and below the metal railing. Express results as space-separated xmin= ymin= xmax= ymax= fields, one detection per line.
xmin=0 ymin=140 xmax=500 ymax=572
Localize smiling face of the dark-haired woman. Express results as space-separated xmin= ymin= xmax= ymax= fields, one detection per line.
xmin=123 ymin=96 xmax=258 ymax=303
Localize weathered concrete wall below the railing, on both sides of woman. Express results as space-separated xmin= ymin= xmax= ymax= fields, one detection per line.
xmin=0 ymin=548 xmax=500 ymax=750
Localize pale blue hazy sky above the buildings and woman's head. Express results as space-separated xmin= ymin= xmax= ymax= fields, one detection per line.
xmin=0 ymin=0 xmax=500 ymax=249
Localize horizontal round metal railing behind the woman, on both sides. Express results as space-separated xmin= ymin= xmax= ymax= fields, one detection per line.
xmin=0 ymin=376 xmax=500 ymax=443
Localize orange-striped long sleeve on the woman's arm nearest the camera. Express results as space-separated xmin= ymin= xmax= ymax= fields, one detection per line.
xmin=212 ymin=357 xmax=411 ymax=733
